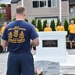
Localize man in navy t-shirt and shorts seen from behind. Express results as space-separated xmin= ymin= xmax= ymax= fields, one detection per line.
xmin=2 ymin=6 xmax=39 ymax=75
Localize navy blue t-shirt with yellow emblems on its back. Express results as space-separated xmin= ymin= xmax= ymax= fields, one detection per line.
xmin=2 ymin=20 xmax=38 ymax=52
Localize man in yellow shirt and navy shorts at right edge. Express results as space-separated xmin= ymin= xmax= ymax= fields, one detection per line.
xmin=68 ymin=20 xmax=75 ymax=49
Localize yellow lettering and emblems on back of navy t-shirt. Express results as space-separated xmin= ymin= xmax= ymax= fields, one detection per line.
xmin=8 ymin=26 xmax=26 ymax=43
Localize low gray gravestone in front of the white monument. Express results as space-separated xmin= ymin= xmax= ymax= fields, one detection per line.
xmin=34 ymin=61 xmax=59 ymax=75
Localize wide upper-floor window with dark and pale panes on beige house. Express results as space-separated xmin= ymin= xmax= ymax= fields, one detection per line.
xmin=32 ymin=0 xmax=56 ymax=8
